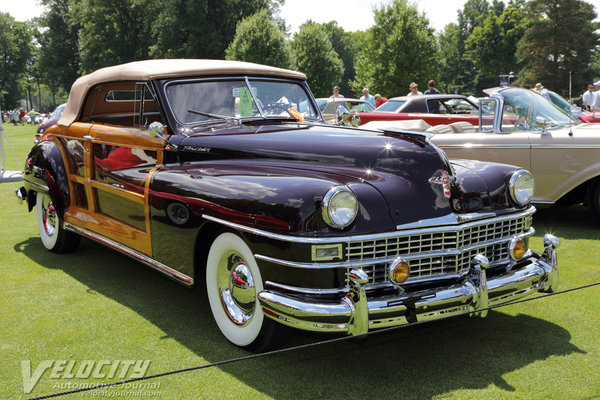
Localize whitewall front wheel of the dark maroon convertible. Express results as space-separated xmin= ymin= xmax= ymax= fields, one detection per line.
xmin=206 ymin=232 xmax=287 ymax=352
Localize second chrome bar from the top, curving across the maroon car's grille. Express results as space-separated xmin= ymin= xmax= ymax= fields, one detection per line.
xmin=254 ymin=227 xmax=535 ymax=270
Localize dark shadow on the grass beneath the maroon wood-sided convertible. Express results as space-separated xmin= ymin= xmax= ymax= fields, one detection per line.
xmin=15 ymin=233 xmax=581 ymax=399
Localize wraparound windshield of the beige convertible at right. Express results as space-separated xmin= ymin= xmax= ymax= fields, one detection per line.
xmin=500 ymin=88 xmax=573 ymax=132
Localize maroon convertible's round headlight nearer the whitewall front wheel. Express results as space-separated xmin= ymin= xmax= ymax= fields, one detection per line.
xmin=322 ymin=186 xmax=358 ymax=229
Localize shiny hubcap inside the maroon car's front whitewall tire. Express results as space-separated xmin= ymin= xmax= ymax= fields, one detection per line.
xmin=217 ymin=251 xmax=256 ymax=326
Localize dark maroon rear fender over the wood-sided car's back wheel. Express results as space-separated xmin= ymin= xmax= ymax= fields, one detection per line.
xmin=23 ymin=140 xmax=70 ymax=215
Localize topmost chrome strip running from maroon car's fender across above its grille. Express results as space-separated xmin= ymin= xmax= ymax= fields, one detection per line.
xmin=202 ymin=206 xmax=535 ymax=244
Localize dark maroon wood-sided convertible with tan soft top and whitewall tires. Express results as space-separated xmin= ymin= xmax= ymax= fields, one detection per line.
xmin=17 ymin=60 xmax=558 ymax=350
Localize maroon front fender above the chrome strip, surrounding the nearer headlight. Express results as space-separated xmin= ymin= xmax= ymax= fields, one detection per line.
xmin=150 ymin=161 xmax=394 ymax=236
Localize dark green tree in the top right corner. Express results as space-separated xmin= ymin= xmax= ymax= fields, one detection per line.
xmin=517 ymin=0 xmax=599 ymax=96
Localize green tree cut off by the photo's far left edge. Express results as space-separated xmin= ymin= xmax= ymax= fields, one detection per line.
xmin=0 ymin=13 xmax=32 ymax=110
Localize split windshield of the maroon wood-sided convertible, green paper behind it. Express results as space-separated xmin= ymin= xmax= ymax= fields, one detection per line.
xmin=166 ymin=78 xmax=319 ymax=124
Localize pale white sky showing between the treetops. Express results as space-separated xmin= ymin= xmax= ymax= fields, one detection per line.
xmin=0 ymin=0 xmax=600 ymax=34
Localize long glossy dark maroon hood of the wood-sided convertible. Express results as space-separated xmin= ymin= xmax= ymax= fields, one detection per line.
xmin=179 ymin=124 xmax=452 ymax=225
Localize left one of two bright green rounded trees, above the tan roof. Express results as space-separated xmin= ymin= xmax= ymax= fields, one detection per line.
xmin=225 ymin=9 xmax=292 ymax=68
